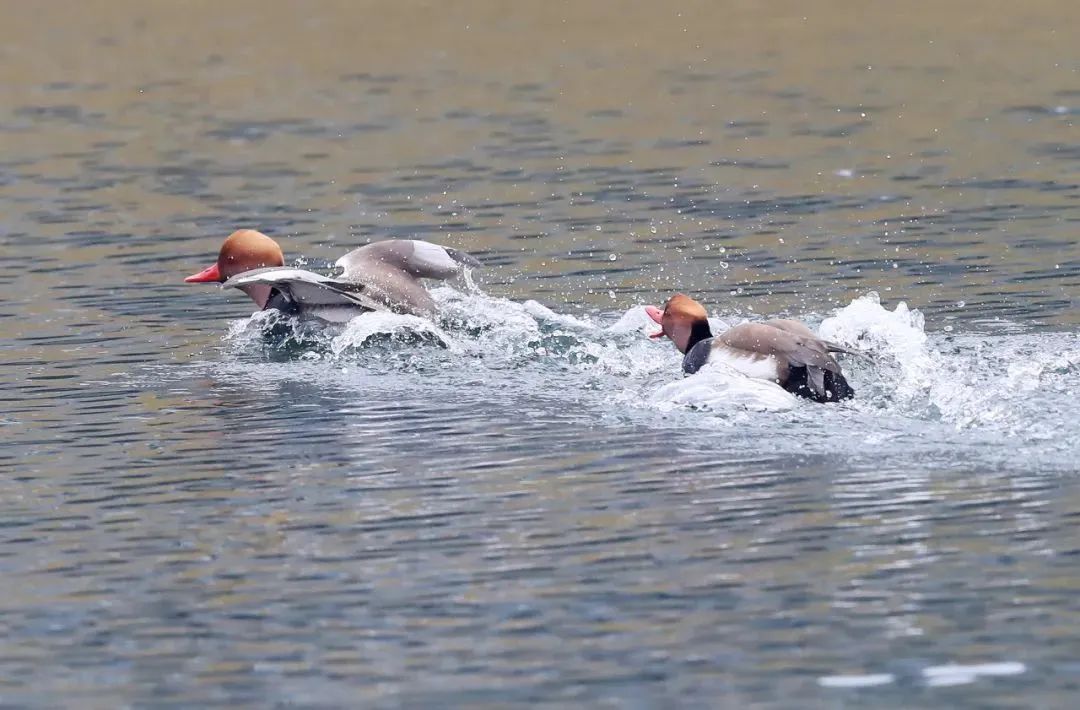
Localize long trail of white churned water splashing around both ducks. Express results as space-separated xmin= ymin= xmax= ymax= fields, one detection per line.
xmin=204 ymin=286 xmax=1080 ymax=463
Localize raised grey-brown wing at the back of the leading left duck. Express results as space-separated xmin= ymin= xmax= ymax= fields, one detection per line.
xmin=337 ymin=239 xmax=480 ymax=314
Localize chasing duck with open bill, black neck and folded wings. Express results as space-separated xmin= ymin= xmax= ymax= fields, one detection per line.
xmin=645 ymin=293 xmax=862 ymax=402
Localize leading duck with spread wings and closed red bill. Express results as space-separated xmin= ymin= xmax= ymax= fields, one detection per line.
xmin=184 ymin=229 xmax=480 ymax=322
